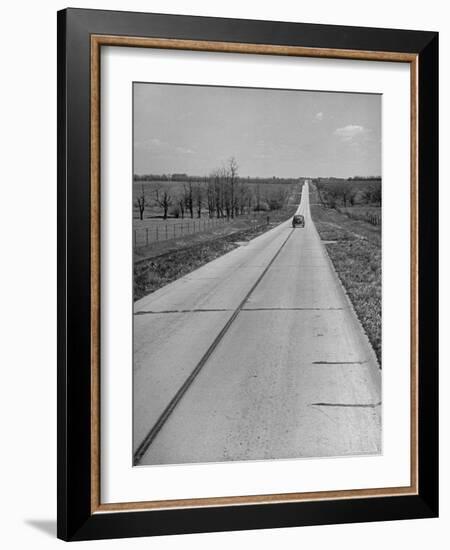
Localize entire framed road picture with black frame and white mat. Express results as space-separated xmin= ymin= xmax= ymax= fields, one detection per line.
xmin=58 ymin=9 xmax=438 ymax=540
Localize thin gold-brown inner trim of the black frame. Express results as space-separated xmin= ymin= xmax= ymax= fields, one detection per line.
xmin=90 ymin=35 xmax=419 ymax=514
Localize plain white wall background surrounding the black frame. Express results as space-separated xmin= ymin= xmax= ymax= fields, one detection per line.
xmin=0 ymin=0 xmax=450 ymax=550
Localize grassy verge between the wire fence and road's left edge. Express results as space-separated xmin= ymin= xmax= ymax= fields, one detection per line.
xmin=133 ymin=206 xmax=296 ymax=300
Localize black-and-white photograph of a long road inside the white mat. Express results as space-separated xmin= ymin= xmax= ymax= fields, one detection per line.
xmin=132 ymin=82 xmax=382 ymax=466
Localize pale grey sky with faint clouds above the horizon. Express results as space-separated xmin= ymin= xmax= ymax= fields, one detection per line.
xmin=133 ymin=83 xmax=381 ymax=177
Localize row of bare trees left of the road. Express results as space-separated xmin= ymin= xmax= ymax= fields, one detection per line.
xmin=135 ymin=157 xmax=287 ymax=220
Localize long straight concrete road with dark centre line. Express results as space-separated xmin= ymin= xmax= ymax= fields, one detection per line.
xmin=134 ymin=183 xmax=381 ymax=464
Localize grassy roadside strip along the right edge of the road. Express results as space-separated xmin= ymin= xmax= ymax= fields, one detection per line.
xmin=311 ymin=188 xmax=381 ymax=365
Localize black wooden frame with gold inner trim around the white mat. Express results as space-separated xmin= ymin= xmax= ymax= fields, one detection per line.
xmin=58 ymin=9 xmax=438 ymax=540
